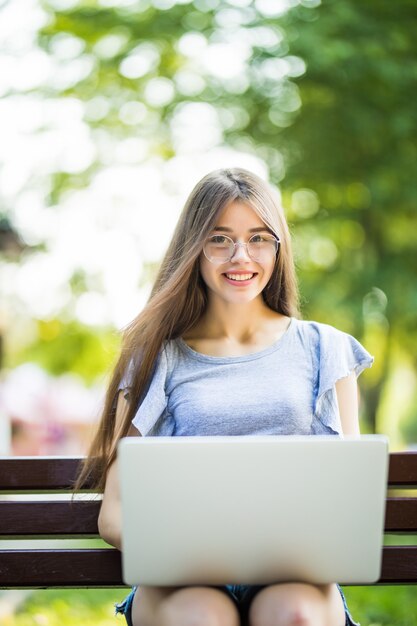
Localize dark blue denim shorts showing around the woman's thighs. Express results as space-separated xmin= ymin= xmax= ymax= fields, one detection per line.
xmin=115 ymin=585 xmax=360 ymax=626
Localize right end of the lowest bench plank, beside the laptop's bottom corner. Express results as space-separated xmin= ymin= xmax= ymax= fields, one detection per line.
xmin=378 ymin=546 xmax=417 ymax=585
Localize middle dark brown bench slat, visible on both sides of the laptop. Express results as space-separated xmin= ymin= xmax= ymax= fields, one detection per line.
xmin=0 ymin=498 xmax=417 ymax=537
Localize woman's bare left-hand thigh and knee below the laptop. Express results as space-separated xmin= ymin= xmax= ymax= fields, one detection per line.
xmin=131 ymin=586 xmax=240 ymax=626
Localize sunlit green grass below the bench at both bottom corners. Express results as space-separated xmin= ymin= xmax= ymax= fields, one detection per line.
xmin=1 ymin=585 xmax=417 ymax=626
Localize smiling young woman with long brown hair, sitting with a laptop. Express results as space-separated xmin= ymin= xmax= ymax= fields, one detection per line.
xmin=80 ymin=169 xmax=372 ymax=626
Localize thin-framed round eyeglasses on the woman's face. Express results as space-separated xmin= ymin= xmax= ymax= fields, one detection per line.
xmin=203 ymin=233 xmax=280 ymax=264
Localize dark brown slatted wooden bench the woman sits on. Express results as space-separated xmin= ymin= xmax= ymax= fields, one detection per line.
xmin=0 ymin=452 xmax=417 ymax=588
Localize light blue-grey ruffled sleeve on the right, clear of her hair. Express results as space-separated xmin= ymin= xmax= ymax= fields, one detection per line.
xmin=312 ymin=324 xmax=374 ymax=435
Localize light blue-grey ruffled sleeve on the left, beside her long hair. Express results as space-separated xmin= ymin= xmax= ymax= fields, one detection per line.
xmin=119 ymin=349 xmax=174 ymax=437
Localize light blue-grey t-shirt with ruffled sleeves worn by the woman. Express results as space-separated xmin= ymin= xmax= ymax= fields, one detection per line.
xmin=119 ymin=318 xmax=373 ymax=436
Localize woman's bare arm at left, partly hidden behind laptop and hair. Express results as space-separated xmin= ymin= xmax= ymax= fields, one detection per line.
xmin=98 ymin=392 xmax=140 ymax=550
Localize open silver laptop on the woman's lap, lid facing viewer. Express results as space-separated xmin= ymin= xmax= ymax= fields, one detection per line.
xmin=118 ymin=435 xmax=388 ymax=586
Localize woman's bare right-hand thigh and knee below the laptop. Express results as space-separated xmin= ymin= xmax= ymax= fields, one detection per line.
xmin=248 ymin=583 xmax=346 ymax=626
